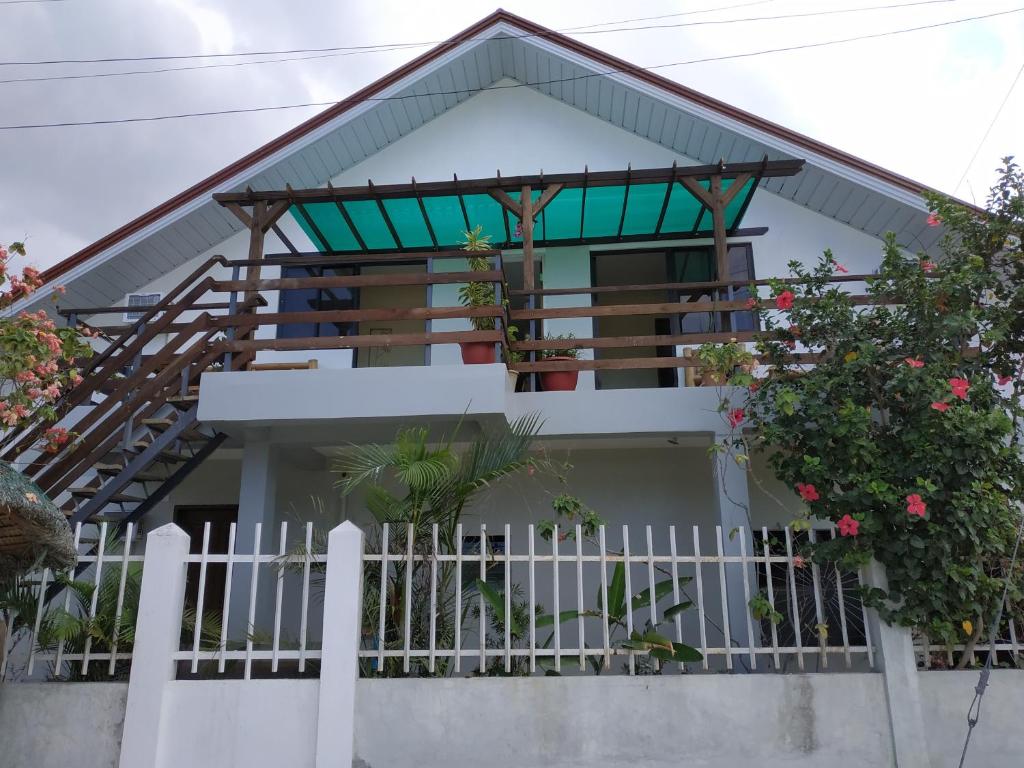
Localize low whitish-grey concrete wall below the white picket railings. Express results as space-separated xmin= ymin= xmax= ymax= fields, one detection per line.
xmin=8 ymin=670 xmax=1024 ymax=768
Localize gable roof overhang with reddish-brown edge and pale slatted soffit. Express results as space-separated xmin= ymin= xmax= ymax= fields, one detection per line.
xmin=25 ymin=9 xmax=950 ymax=304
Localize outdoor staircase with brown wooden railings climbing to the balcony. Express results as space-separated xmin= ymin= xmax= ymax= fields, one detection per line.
xmin=0 ymin=257 xmax=247 ymax=525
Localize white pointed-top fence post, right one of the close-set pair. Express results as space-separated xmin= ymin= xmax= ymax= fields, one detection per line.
xmin=316 ymin=520 xmax=362 ymax=768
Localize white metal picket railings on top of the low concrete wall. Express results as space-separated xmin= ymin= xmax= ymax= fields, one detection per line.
xmin=8 ymin=522 xmax=1020 ymax=679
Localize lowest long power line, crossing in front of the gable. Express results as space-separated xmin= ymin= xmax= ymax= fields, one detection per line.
xmin=0 ymin=7 xmax=1024 ymax=131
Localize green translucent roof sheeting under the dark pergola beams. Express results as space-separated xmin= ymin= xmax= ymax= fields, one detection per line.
xmin=292 ymin=171 xmax=757 ymax=253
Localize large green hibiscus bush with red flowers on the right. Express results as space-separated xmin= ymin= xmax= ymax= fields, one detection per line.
xmin=720 ymin=159 xmax=1024 ymax=658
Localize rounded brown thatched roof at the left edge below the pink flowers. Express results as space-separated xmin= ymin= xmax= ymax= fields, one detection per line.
xmin=0 ymin=462 xmax=76 ymax=581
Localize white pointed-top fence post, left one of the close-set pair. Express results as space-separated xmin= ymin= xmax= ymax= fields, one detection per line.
xmin=119 ymin=523 xmax=188 ymax=768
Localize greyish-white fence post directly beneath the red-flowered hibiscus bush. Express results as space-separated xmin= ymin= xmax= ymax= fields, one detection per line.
xmin=864 ymin=560 xmax=931 ymax=768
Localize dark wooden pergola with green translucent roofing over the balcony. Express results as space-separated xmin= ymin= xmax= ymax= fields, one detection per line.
xmin=214 ymin=157 xmax=804 ymax=291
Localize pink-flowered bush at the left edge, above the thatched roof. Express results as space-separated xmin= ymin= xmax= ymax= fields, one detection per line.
xmin=0 ymin=243 xmax=92 ymax=453
